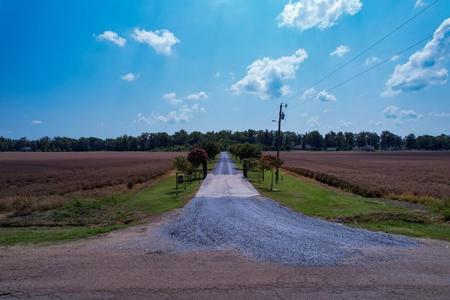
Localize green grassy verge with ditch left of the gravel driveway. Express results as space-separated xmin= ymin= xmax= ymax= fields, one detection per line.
xmin=0 ymin=175 xmax=200 ymax=245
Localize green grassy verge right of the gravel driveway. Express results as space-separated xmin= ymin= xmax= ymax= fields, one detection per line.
xmin=237 ymin=163 xmax=450 ymax=241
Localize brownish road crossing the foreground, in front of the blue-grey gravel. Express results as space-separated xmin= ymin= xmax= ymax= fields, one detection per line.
xmin=0 ymin=211 xmax=450 ymax=299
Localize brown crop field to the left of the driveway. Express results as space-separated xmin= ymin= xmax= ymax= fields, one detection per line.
xmin=0 ymin=152 xmax=181 ymax=212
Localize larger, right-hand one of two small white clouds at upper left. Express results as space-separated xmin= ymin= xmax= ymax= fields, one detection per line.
xmin=132 ymin=28 xmax=180 ymax=55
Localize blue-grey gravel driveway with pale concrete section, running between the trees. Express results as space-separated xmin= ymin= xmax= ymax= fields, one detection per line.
xmin=156 ymin=152 xmax=417 ymax=265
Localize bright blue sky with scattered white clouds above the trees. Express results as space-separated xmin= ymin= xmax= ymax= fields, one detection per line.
xmin=0 ymin=0 xmax=450 ymax=138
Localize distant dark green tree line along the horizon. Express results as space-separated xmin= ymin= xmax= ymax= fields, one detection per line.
xmin=0 ymin=129 xmax=450 ymax=152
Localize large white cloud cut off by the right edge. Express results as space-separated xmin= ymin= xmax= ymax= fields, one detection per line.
xmin=382 ymin=18 xmax=450 ymax=96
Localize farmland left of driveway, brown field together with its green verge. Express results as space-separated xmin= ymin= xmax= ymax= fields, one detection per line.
xmin=0 ymin=152 xmax=205 ymax=245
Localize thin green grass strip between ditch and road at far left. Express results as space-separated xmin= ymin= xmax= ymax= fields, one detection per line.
xmin=0 ymin=225 xmax=124 ymax=246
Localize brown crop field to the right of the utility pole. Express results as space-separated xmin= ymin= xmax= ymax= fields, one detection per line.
xmin=281 ymin=151 xmax=450 ymax=202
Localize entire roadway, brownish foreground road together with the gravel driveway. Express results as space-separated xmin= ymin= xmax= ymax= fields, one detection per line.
xmin=0 ymin=153 xmax=450 ymax=299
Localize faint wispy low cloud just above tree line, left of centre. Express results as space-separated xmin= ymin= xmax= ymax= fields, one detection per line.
xmin=135 ymin=103 xmax=205 ymax=124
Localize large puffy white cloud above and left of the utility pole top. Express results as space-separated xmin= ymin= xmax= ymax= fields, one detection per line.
xmin=231 ymin=49 xmax=308 ymax=100
